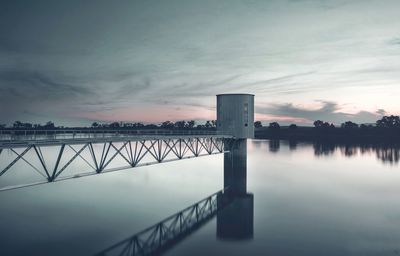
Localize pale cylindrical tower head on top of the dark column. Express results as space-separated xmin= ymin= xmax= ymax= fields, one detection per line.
xmin=217 ymin=94 xmax=254 ymax=139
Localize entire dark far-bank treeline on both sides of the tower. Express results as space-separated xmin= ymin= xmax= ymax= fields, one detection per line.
xmin=0 ymin=115 xmax=400 ymax=141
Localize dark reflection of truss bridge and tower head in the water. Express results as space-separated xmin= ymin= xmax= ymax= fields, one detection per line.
xmin=96 ymin=189 xmax=253 ymax=256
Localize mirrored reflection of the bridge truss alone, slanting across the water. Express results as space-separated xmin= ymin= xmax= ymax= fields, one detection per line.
xmin=96 ymin=189 xmax=228 ymax=256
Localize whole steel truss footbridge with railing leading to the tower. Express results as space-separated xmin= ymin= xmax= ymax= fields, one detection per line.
xmin=0 ymin=130 xmax=233 ymax=191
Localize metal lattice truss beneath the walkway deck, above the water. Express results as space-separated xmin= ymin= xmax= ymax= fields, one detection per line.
xmin=0 ymin=135 xmax=225 ymax=191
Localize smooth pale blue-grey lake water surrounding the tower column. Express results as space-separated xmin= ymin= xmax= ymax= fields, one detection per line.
xmin=0 ymin=140 xmax=400 ymax=256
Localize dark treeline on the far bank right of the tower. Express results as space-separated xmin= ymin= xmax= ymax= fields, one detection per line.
xmin=255 ymin=115 xmax=400 ymax=141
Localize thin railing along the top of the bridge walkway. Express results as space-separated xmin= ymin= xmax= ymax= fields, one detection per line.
xmin=0 ymin=129 xmax=221 ymax=141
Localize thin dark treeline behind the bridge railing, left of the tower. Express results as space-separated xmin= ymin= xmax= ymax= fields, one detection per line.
xmin=0 ymin=120 xmax=217 ymax=130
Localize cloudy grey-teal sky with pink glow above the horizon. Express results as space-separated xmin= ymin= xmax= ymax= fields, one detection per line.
xmin=0 ymin=0 xmax=400 ymax=125
